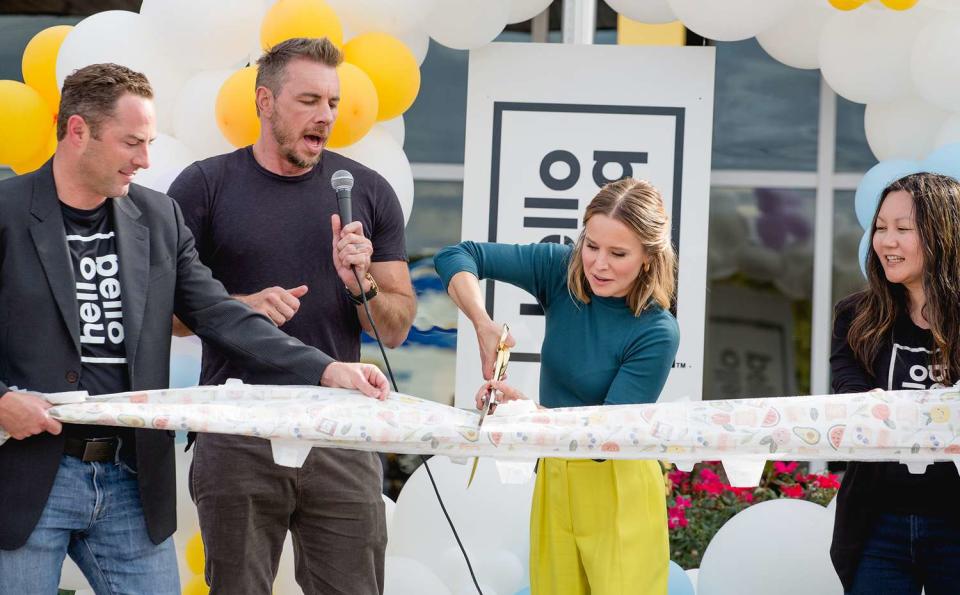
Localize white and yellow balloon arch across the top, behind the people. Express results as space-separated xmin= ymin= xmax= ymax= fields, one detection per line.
xmin=0 ymin=0 xmax=960 ymax=200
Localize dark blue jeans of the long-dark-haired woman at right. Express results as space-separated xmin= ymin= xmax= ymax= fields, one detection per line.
xmin=847 ymin=514 xmax=960 ymax=595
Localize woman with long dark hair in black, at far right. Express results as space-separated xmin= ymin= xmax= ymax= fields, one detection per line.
xmin=830 ymin=173 xmax=960 ymax=595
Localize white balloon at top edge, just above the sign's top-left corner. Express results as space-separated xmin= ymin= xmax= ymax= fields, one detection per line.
xmin=423 ymin=0 xmax=510 ymax=50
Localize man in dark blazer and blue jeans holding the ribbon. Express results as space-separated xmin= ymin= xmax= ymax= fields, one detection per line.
xmin=0 ymin=64 xmax=388 ymax=595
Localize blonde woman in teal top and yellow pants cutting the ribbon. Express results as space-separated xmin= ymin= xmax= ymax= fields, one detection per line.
xmin=435 ymin=178 xmax=679 ymax=595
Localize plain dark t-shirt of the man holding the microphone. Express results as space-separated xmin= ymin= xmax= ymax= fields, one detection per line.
xmin=168 ymin=147 xmax=406 ymax=384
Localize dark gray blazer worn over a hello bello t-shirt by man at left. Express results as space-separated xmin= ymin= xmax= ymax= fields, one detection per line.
xmin=0 ymin=160 xmax=332 ymax=549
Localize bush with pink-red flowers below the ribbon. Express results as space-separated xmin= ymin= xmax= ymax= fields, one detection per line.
xmin=665 ymin=461 xmax=840 ymax=568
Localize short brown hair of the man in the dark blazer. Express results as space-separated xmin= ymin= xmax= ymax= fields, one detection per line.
xmin=57 ymin=63 xmax=153 ymax=140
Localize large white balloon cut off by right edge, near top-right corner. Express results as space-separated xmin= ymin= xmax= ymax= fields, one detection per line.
xmin=910 ymin=16 xmax=960 ymax=111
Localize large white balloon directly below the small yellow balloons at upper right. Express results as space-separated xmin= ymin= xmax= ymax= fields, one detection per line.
xmin=819 ymin=7 xmax=925 ymax=103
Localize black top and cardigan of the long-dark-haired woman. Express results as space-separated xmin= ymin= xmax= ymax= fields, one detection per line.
xmin=830 ymin=294 xmax=960 ymax=588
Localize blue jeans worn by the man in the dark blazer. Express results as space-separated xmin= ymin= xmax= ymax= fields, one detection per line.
xmin=0 ymin=455 xmax=180 ymax=595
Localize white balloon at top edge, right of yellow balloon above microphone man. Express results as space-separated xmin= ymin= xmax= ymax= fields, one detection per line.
xmin=327 ymin=0 xmax=438 ymax=36
